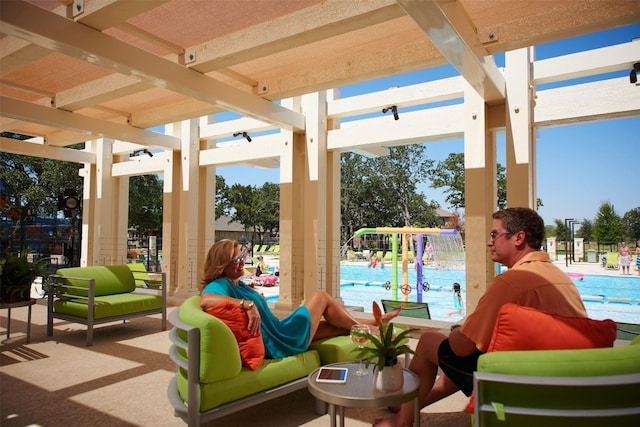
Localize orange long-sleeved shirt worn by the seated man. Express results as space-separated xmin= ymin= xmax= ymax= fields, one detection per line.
xmin=460 ymin=251 xmax=587 ymax=352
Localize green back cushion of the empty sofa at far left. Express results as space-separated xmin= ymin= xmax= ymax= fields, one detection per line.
xmin=56 ymin=265 xmax=136 ymax=296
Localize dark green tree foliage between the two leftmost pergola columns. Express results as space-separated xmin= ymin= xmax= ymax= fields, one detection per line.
xmin=129 ymin=175 xmax=164 ymax=236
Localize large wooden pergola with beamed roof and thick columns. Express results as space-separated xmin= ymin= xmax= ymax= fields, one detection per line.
xmin=0 ymin=0 xmax=640 ymax=310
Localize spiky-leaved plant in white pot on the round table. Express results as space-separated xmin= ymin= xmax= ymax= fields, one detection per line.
xmin=354 ymin=301 xmax=417 ymax=391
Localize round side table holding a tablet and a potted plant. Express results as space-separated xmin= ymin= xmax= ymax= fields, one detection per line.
xmin=307 ymin=362 xmax=420 ymax=427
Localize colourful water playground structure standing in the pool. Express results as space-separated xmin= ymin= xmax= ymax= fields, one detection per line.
xmin=350 ymin=227 xmax=464 ymax=302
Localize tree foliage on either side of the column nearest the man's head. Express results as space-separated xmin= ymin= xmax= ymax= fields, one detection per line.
xmin=427 ymin=153 xmax=507 ymax=209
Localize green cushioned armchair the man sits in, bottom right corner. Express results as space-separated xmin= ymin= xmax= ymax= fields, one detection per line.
xmin=473 ymin=337 xmax=640 ymax=427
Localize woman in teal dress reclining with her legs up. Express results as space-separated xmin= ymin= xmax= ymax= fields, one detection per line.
xmin=199 ymin=240 xmax=400 ymax=359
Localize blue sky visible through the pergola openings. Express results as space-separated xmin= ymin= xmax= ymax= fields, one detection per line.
xmin=217 ymin=24 xmax=640 ymax=224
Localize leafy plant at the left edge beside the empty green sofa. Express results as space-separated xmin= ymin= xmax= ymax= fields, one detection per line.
xmin=0 ymin=251 xmax=46 ymax=303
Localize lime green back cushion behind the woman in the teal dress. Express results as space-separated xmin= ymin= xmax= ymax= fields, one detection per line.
xmin=180 ymin=295 xmax=242 ymax=383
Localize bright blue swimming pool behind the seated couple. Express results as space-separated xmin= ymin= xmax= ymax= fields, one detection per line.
xmin=270 ymin=265 xmax=640 ymax=323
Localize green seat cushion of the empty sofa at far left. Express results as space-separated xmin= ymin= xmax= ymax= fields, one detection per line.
xmin=54 ymin=293 xmax=162 ymax=320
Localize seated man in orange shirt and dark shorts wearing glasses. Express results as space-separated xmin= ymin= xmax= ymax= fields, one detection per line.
xmin=373 ymin=208 xmax=587 ymax=427
